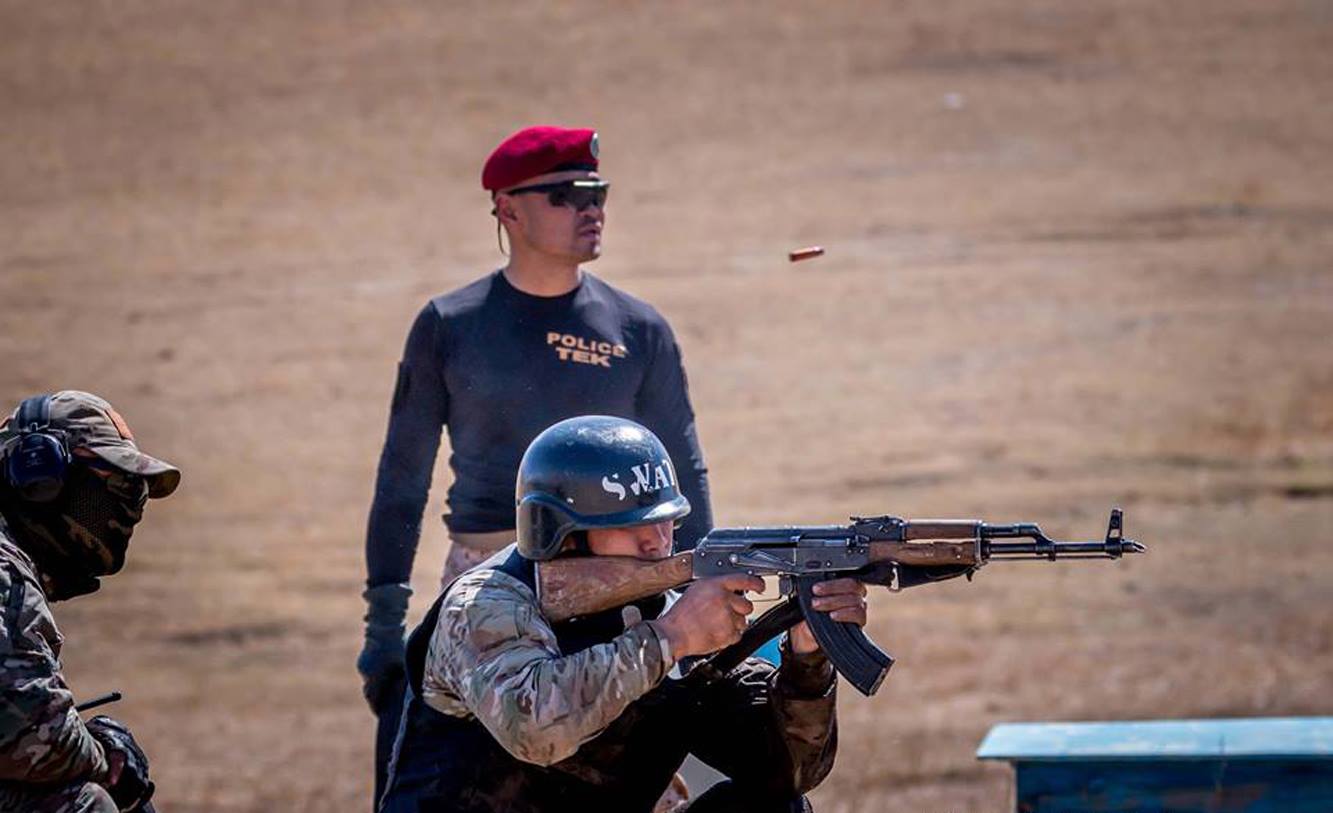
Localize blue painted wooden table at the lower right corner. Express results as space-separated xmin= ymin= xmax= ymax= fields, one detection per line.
xmin=977 ymin=717 xmax=1333 ymax=813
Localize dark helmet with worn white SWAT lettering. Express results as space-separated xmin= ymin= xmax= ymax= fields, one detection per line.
xmin=515 ymin=414 xmax=689 ymax=561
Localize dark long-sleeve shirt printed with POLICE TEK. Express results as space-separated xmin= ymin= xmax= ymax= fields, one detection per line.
xmin=365 ymin=272 xmax=712 ymax=586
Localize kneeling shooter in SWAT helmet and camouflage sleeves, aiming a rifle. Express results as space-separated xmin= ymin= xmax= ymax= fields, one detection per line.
xmin=381 ymin=416 xmax=865 ymax=813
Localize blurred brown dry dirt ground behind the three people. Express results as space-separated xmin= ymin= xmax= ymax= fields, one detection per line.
xmin=0 ymin=0 xmax=1333 ymax=813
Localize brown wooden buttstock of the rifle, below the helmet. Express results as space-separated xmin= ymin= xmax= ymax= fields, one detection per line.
xmin=537 ymin=552 xmax=694 ymax=621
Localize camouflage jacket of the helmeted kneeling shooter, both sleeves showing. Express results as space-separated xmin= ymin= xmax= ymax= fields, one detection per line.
xmin=421 ymin=554 xmax=836 ymax=789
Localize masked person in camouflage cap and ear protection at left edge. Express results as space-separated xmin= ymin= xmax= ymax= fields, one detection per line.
xmin=0 ymin=391 xmax=180 ymax=813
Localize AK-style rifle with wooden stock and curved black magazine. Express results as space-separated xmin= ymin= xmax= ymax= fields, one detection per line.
xmin=537 ymin=508 xmax=1146 ymax=696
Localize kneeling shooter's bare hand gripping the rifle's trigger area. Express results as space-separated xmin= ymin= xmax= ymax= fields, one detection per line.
xmin=652 ymin=573 xmax=764 ymax=658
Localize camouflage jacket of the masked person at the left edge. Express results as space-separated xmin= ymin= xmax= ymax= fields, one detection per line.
xmin=0 ymin=520 xmax=107 ymax=789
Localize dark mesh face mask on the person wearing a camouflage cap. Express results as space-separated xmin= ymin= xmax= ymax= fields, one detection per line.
xmin=0 ymin=458 xmax=148 ymax=601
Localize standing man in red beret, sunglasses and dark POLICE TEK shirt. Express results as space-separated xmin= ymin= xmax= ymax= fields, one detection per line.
xmin=357 ymin=127 xmax=712 ymax=798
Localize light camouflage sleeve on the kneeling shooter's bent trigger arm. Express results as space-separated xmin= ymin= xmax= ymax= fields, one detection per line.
xmin=425 ymin=570 xmax=670 ymax=765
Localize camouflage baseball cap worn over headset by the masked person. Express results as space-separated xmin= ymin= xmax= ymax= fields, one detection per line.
xmin=3 ymin=389 xmax=180 ymax=497
